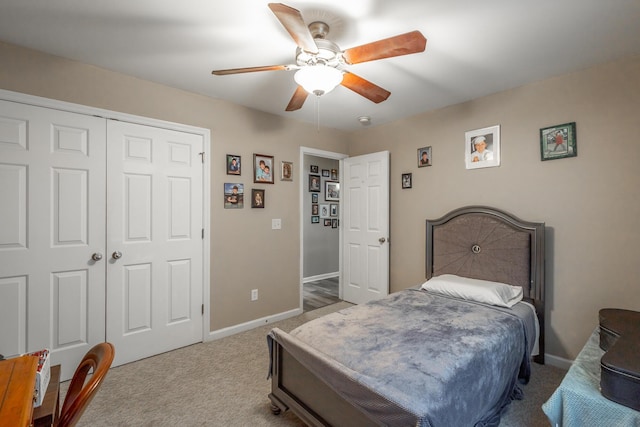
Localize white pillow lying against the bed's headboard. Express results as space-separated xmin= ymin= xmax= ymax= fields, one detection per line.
xmin=421 ymin=274 xmax=522 ymax=307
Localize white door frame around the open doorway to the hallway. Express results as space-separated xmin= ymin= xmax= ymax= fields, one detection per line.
xmin=298 ymin=146 xmax=349 ymax=313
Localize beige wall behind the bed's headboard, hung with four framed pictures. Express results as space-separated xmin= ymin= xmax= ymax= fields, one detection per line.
xmin=349 ymin=57 xmax=640 ymax=359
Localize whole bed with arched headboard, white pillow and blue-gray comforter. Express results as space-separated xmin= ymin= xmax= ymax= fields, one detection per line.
xmin=267 ymin=206 xmax=544 ymax=426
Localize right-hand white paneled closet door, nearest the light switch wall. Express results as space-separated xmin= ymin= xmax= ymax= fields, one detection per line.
xmin=107 ymin=121 xmax=203 ymax=365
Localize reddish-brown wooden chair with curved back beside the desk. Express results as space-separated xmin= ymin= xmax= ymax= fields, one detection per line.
xmin=55 ymin=342 xmax=115 ymax=427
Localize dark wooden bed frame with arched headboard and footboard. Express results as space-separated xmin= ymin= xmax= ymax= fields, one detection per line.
xmin=269 ymin=206 xmax=544 ymax=426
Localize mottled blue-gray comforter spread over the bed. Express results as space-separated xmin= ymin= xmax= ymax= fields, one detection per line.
xmin=269 ymin=289 xmax=535 ymax=427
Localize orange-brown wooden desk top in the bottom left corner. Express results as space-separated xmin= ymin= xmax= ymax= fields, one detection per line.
xmin=0 ymin=356 xmax=38 ymax=427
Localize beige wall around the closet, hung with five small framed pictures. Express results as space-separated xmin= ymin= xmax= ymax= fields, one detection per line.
xmin=0 ymin=42 xmax=348 ymax=331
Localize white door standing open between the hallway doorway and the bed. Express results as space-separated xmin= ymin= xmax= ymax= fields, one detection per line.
xmin=341 ymin=151 xmax=389 ymax=304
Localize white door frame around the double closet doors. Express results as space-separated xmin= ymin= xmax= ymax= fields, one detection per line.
xmin=0 ymin=89 xmax=211 ymax=342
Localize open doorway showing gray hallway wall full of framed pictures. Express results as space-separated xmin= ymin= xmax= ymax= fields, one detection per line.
xmin=300 ymin=147 xmax=347 ymax=311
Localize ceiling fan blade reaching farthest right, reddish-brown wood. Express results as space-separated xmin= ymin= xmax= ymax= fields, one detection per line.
xmin=343 ymin=31 xmax=427 ymax=64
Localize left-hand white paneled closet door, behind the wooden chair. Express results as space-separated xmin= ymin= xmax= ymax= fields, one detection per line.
xmin=0 ymin=101 xmax=106 ymax=378
